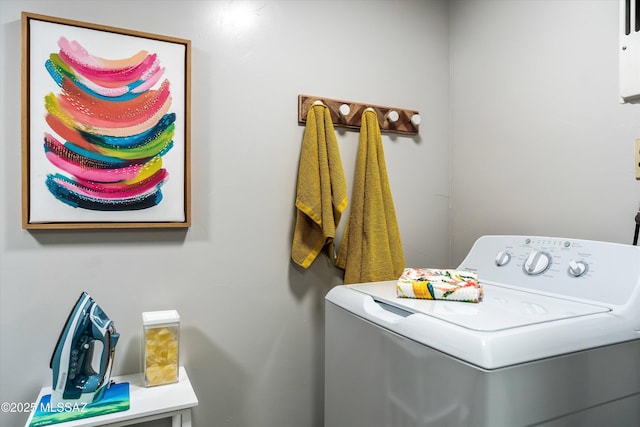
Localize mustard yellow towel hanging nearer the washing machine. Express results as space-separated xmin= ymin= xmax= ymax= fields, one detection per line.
xmin=336 ymin=110 xmax=405 ymax=283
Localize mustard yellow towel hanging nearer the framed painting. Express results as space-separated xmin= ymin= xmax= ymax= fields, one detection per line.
xmin=291 ymin=105 xmax=347 ymax=268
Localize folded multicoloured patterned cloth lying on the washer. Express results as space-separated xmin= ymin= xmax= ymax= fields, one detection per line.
xmin=396 ymin=268 xmax=482 ymax=302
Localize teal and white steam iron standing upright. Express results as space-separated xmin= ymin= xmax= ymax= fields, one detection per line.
xmin=49 ymin=292 xmax=120 ymax=405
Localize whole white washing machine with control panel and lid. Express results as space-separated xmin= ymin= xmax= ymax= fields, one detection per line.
xmin=324 ymin=236 xmax=640 ymax=427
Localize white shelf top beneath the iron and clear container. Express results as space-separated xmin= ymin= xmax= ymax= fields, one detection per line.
xmin=25 ymin=367 xmax=198 ymax=427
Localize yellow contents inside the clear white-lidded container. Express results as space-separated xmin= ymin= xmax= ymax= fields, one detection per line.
xmin=144 ymin=328 xmax=178 ymax=385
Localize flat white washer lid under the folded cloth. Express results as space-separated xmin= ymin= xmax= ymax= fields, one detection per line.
xmin=347 ymin=281 xmax=611 ymax=332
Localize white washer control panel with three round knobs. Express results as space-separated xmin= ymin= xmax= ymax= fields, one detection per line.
xmin=459 ymin=236 xmax=640 ymax=305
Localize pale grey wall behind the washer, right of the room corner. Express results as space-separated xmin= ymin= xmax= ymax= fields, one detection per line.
xmin=451 ymin=0 xmax=640 ymax=264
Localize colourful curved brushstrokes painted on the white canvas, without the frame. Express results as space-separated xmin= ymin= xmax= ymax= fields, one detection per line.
xmin=43 ymin=37 xmax=176 ymax=211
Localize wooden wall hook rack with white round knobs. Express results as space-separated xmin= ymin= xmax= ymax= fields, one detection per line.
xmin=298 ymin=95 xmax=420 ymax=135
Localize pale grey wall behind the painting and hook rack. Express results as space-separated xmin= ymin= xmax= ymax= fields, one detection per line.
xmin=0 ymin=0 xmax=450 ymax=427
